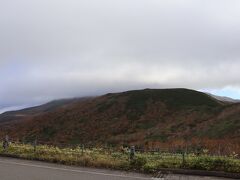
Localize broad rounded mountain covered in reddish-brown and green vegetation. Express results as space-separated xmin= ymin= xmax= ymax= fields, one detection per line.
xmin=0 ymin=89 xmax=240 ymax=152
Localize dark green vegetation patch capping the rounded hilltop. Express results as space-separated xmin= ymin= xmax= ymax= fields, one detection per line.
xmin=121 ymin=89 xmax=221 ymax=120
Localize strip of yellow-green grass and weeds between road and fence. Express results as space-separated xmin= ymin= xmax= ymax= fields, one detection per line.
xmin=0 ymin=143 xmax=240 ymax=173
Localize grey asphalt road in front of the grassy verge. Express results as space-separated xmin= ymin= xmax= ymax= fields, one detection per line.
xmin=0 ymin=157 xmax=231 ymax=180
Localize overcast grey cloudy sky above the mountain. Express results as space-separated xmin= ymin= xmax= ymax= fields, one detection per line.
xmin=0 ymin=0 xmax=240 ymax=112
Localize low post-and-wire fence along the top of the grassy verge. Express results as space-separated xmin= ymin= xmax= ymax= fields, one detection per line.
xmin=0 ymin=136 xmax=239 ymax=160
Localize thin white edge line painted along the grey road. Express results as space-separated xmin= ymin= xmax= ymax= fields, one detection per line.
xmin=0 ymin=160 xmax=151 ymax=180
